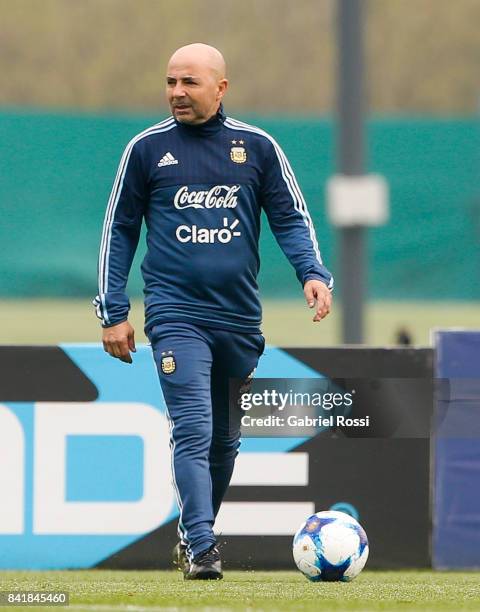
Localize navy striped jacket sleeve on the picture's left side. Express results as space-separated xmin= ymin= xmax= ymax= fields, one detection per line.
xmin=93 ymin=141 xmax=146 ymax=327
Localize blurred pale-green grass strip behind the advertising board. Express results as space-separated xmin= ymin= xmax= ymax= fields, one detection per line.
xmin=0 ymin=298 xmax=480 ymax=346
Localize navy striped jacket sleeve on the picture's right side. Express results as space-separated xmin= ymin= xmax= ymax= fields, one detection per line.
xmin=262 ymin=139 xmax=333 ymax=290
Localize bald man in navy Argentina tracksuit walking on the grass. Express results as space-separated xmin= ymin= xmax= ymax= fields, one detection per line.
xmin=94 ymin=43 xmax=333 ymax=579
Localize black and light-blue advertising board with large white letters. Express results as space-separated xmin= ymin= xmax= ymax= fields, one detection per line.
xmin=0 ymin=344 xmax=432 ymax=569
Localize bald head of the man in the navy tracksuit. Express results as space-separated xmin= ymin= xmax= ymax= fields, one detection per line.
xmin=167 ymin=43 xmax=228 ymax=124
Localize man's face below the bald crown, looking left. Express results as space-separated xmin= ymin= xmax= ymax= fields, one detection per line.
xmin=167 ymin=58 xmax=227 ymax=124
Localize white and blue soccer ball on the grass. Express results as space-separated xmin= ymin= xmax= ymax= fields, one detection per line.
xmin=293 ymin=510 xmax=368 ymax=582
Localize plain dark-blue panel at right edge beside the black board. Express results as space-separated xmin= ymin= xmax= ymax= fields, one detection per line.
xmin=433 ymin=331 xmax=480 ymax=569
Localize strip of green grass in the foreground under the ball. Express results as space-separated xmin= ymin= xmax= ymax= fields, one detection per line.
xmin=0 ymin=570 xmax=480 ymax=612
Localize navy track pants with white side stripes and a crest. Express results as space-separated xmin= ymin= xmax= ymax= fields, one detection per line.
xmin=149 ymin=322 xmax=265 ymax=558
